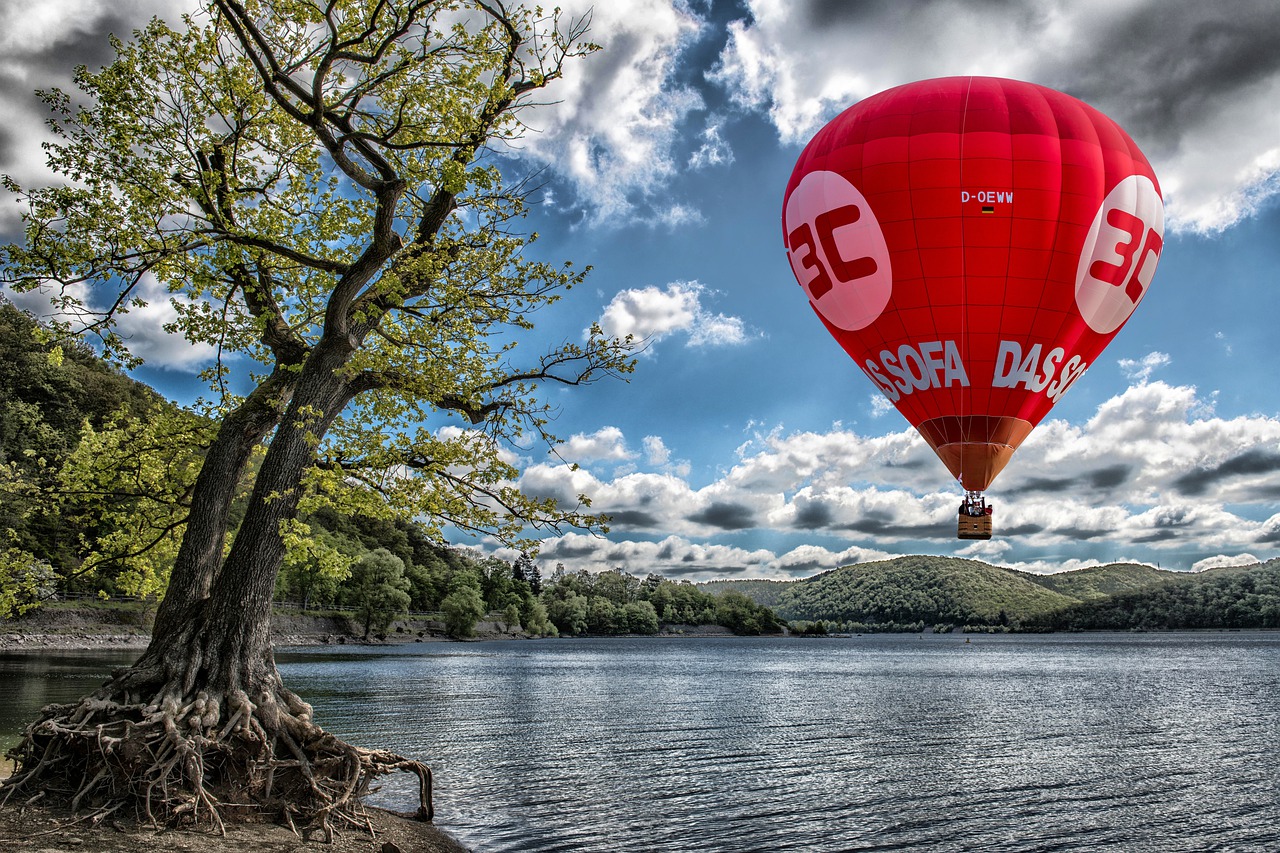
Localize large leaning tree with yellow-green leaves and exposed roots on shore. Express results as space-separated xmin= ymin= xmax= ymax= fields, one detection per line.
xmin=3 ymin=0 xmax=632 ymax=829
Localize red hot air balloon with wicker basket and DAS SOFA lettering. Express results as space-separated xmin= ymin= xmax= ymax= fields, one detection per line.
xmin=782 ymin=77 xmax=1165 ymax=539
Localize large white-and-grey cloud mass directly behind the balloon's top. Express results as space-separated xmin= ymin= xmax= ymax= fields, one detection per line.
xmin=714 ymin=0 xmax=1280 ymax=232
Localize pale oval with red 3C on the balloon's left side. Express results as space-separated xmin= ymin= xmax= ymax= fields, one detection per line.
xmin=782 ymin=170 xmax=893 ymax=332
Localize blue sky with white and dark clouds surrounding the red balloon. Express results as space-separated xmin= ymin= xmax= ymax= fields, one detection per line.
xmin=0 ymin=0 xmax=1280 ymax=580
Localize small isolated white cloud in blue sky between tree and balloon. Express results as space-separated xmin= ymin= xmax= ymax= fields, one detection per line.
xmin=599 ymin=282 xmax=748 ymax=347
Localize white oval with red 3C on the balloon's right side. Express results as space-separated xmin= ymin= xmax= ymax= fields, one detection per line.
xmin=1075 ymin=174 xmax=1165 ymax=334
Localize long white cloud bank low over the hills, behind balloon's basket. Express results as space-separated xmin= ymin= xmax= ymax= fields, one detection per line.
xmin=506 ymin=379 xmax=1280 ymax=579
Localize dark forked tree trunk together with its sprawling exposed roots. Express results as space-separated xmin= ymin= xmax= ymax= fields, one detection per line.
xmin=4 ymin=343 xmax=431 ymax=835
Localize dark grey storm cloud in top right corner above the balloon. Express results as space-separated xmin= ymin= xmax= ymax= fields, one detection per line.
xmin=803 ymin=0 xmax=1280 ymax=155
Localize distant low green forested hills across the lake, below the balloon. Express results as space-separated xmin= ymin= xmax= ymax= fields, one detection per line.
xmin=705 ymin=556 xmax=1280 ymax=630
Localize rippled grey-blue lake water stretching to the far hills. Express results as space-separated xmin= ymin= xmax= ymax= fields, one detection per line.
xmin=0 ymin=633 xmax=1280 ymax=853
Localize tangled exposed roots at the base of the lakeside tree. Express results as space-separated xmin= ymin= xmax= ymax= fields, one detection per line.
xmin=0 ymin=667 xmax=433 ymax=839
